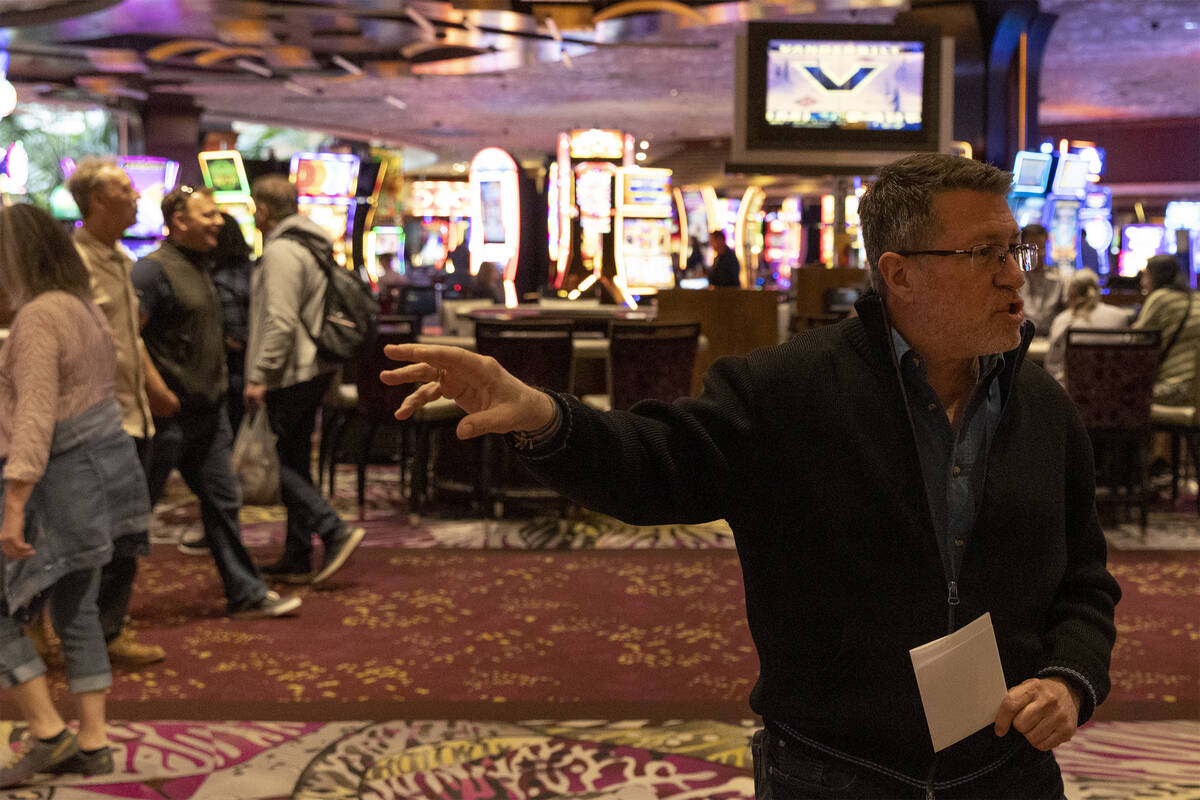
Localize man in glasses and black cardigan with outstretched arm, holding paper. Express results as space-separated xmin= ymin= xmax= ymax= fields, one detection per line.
xmin=384 ymin=154 xmax=1121 ymax=799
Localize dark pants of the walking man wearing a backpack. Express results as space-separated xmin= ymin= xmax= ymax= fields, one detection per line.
xmin=266 ymin=373 xmax=342 ymax=571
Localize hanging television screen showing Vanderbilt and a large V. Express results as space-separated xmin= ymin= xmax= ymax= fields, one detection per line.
xmin=726 ymin=22 xmax=953 ymax=173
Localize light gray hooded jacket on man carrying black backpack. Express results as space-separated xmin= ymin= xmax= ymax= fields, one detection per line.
xmin=246 ymin=213 xmax=335 ymax=389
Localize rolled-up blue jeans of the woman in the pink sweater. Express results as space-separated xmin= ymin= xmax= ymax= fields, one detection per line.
xmin=0 ymin=566 xmax=113 ymax=694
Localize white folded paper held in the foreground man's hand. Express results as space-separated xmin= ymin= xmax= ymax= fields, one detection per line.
xmin=908 ymin=614 xmax=1008 ymax=751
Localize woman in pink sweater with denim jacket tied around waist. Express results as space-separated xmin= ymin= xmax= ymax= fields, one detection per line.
xmin=0 ymin=205 xmax=150 ymax=787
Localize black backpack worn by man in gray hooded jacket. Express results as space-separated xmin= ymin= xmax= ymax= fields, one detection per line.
xmin=280 ymin=228 xmax=379 ymax=363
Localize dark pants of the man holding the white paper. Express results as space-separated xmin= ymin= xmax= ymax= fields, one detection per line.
xmin=751 ymin=730 xmax=1066 ymax=800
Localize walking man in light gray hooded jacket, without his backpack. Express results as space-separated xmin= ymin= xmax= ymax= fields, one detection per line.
xmin=245 ymin=175 xmax=365 ymax=584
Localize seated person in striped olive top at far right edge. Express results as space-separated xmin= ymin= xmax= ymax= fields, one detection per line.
xmin=1133 ymin=253 xmax=1200 ymax=405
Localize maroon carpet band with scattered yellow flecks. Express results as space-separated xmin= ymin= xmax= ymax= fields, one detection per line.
xmin=30 ymin=546 xmax=1200 ymax=721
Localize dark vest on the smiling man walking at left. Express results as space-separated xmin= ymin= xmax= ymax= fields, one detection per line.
xmin=142 ymin=239 xmax=227 ymax=409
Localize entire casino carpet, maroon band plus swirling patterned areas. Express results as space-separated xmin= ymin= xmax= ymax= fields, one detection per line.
xmin=0 ymin=465 xmax=1200 ymax=800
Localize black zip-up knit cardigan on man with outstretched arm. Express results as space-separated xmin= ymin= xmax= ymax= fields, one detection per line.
xmin=526 ymin=293 xmax=1121 ymax=787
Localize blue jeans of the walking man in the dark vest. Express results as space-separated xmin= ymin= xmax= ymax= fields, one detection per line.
xmin=146 ymin=403 xmax=266 ymax=612
